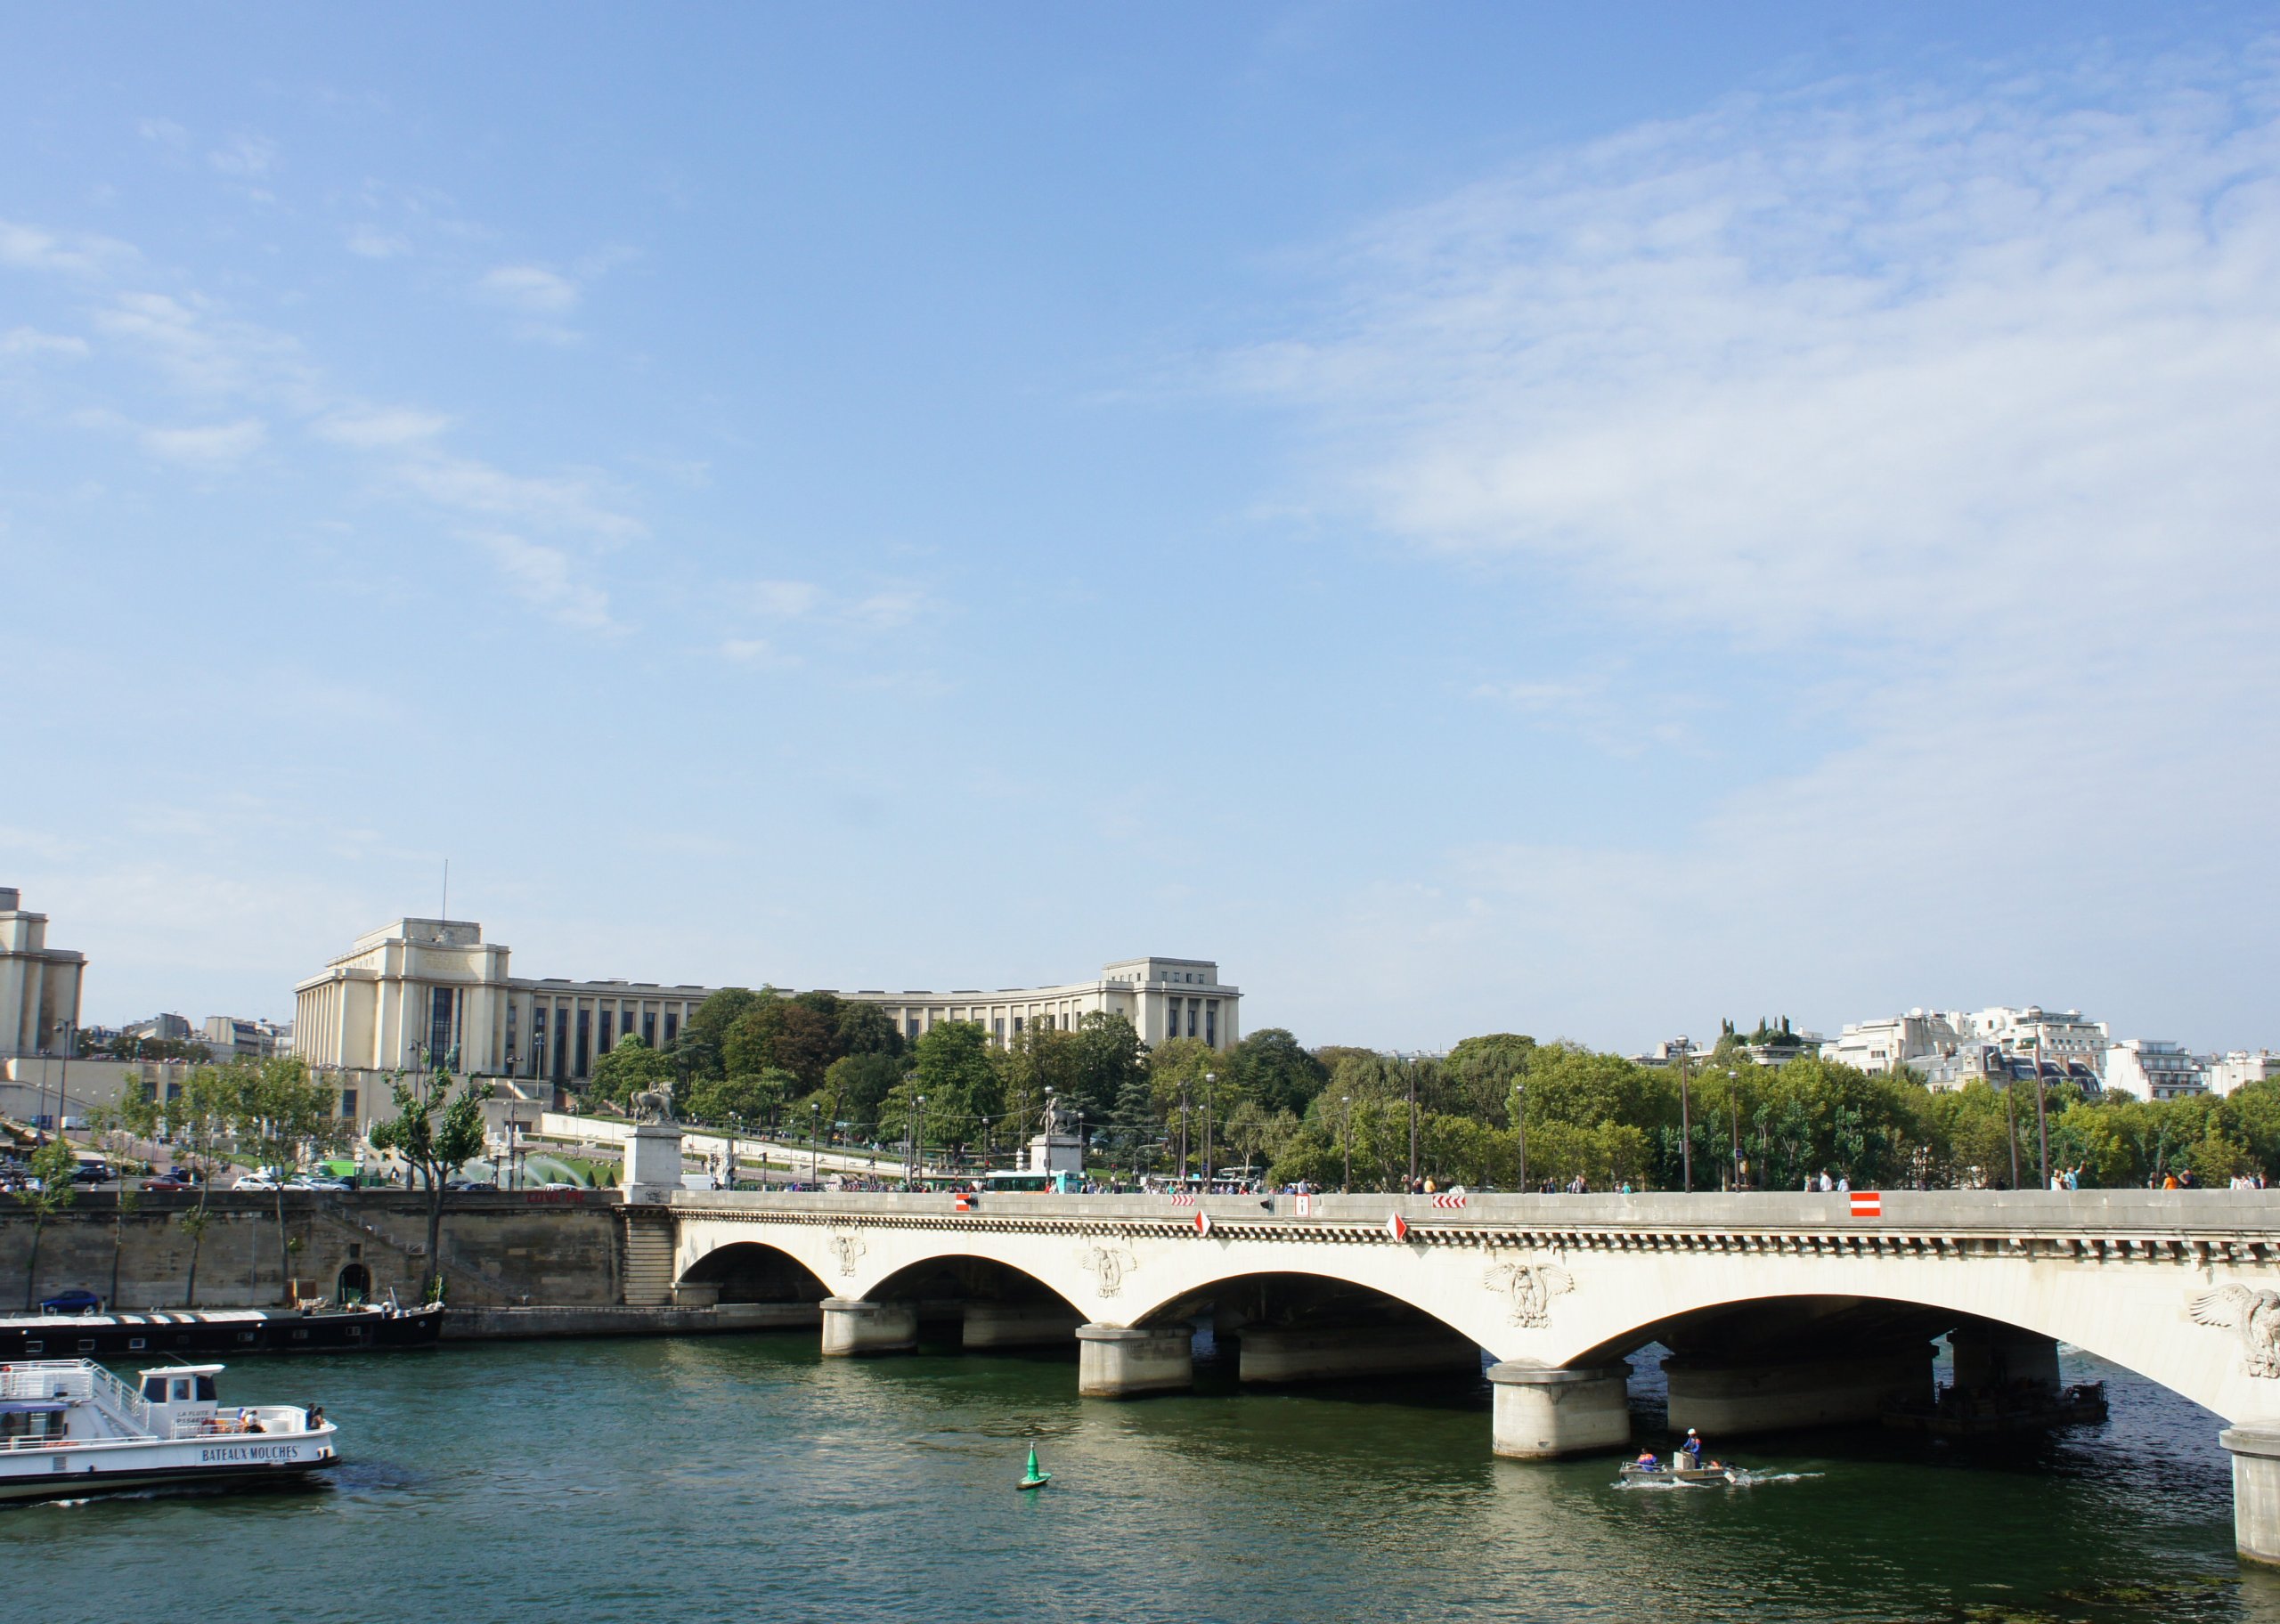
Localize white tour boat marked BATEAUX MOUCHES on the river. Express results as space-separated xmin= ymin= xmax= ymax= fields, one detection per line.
xmin=0 ymin=1360 xmax=339 ymax=1501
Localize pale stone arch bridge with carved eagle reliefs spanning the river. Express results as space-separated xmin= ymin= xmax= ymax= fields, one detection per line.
xmin=656 ymin=1190 xmax=2280 ymax=1560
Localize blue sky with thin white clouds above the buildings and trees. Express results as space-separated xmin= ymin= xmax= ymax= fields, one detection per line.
xmin=0 ymin=4 xmax=2280 ymax=1047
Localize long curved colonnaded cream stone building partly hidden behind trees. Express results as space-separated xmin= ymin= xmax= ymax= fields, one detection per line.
xmin=292 ymin=919 xmax=1242 ymax=1084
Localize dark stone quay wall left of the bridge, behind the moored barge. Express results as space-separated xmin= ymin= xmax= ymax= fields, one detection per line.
xmin=0 ymin=1190 xmax=624 ymax=1314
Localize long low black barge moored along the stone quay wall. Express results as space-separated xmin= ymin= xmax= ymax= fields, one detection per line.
xmin=0 ymin=1303 xmax=443 ymax=1360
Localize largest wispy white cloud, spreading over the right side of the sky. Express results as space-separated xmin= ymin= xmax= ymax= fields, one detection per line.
xmin=1231 ymin=50 xmax=2280 ymax=1035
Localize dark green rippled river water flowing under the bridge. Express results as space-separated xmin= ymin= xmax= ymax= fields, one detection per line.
xmin=18 ymin=1332 xmax=2280 ymax=1624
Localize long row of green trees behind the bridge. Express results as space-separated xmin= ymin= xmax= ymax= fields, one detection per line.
xmin=574 ymin=990 xmax=2280 ymax=1189
